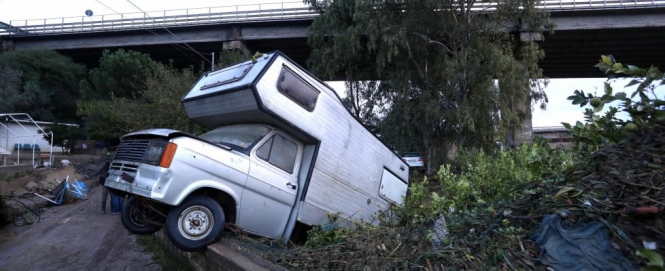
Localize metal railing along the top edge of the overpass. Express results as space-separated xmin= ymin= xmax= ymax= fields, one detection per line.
xmin=0 ymin=0 xmax=665 ymax=36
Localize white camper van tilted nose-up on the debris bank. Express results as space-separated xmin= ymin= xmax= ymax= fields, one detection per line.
xmin=105 ymin=52 xmax=409 ymax=251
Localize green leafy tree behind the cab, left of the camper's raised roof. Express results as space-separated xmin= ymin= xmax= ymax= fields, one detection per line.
xmin=78 ymin=50 xmax=249 ymax=140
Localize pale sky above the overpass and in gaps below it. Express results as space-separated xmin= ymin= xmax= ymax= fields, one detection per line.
xmin=0 ymin=0 xmax=665 ymax=127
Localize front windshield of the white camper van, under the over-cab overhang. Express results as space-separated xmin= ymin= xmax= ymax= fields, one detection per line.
xmin=200 ymin=124 xmax=270 ymax=154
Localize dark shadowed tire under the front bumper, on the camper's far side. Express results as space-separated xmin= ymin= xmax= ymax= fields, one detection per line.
xmin=120 ymin=197 xmax=162 ymax=235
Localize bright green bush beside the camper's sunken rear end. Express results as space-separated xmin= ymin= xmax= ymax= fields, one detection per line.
xmin=397 ymin=141 xmax=575 ymax=224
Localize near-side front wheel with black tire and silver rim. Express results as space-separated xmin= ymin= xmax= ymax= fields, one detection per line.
xmin=166 ymin=196 xmax=226 ymax=252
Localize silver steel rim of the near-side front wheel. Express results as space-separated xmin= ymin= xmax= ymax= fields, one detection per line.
xmin=178 ymin=205 xmax=215 ymax=240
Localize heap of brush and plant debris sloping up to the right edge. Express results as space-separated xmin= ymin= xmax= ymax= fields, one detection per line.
xmin=250 ymin=122 xmax=665 ymax=270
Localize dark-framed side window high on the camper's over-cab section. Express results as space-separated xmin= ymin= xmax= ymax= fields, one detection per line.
xmin=277 ymin=66 xmax=319 ymax=111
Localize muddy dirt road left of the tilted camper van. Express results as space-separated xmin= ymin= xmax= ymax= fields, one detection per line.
xmin=0 ymin=172 xmax=162 ymax=271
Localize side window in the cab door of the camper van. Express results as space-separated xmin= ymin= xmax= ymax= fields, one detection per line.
xmin=256 ymin=135 xmax=298 ymax=173
